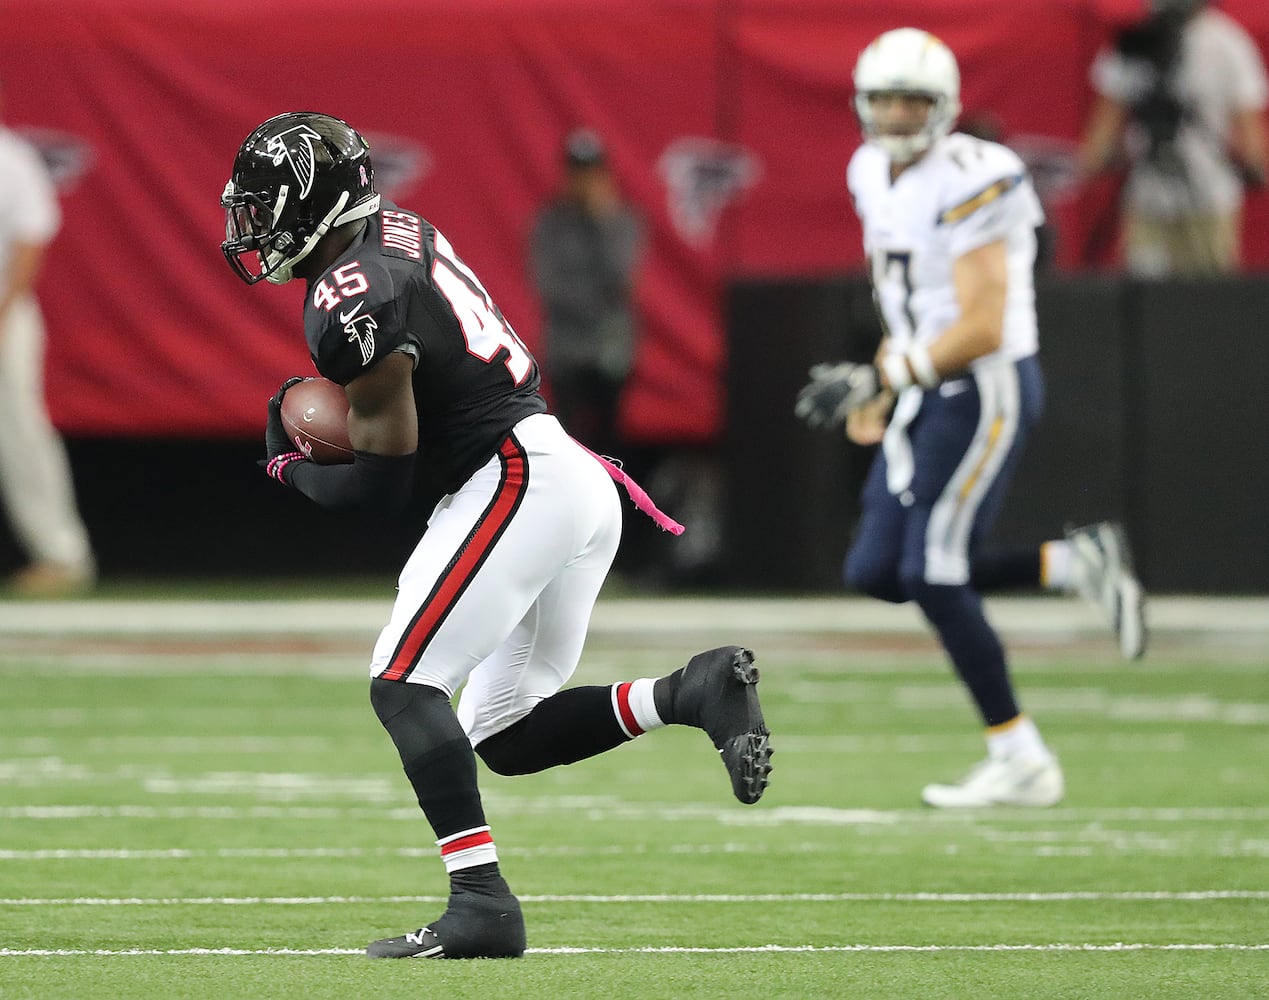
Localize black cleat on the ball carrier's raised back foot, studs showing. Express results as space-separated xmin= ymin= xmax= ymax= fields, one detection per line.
xmin=674 ymin=646 xmax=773 ymax=805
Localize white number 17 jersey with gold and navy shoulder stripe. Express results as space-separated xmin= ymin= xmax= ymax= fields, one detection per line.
xmin=846 ymin=132 xmax=1044 ymax=364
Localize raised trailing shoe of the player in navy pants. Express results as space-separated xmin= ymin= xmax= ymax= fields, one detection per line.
xmin=1066 ymin=520 xmax=1146 ymax=660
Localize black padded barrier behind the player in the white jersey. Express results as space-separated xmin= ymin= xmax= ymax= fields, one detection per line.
xmin=725 ymin=275 xmax=1269 ymax=594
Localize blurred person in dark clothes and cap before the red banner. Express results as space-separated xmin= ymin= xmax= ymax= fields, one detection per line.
xmin=529 ymin=128 xmax=643 ymax=456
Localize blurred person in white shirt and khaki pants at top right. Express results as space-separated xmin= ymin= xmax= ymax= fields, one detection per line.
xmin=1079 ymin=0 xmax=1266 ymax=278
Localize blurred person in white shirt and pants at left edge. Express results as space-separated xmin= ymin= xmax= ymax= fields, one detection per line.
xmin=0 ymin=79 xmax=95 ymax=598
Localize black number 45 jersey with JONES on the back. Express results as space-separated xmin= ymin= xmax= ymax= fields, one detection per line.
xmin=305 ymin=201 xmax=547 ymax=503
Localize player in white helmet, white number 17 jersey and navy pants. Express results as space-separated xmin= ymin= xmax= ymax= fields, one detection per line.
xmin=797 ymin=28 xmax=1143 ymax=807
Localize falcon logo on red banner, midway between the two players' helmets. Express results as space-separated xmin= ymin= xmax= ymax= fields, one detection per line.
xmin=657 ymin=136 xmax=763 ymax=246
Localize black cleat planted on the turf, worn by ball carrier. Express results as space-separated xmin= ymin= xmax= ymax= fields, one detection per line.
xmin=365 ymin=887 xmax=524 ymax=958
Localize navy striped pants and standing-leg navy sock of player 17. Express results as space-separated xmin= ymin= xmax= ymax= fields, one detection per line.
xmin=844 ymin=357 xmax=1044 ymax=726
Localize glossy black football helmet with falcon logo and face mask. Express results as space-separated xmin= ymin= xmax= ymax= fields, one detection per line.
xmin=221 ymin=112 xmax=379 ymax=284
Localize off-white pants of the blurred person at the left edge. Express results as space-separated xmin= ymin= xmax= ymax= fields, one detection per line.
xmin=0 ymin=296 xmax=93 ymax=570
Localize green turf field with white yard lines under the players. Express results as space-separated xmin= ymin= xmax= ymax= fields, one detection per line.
xmin=0 ymin=596 xmax=1269 ymax=1000
